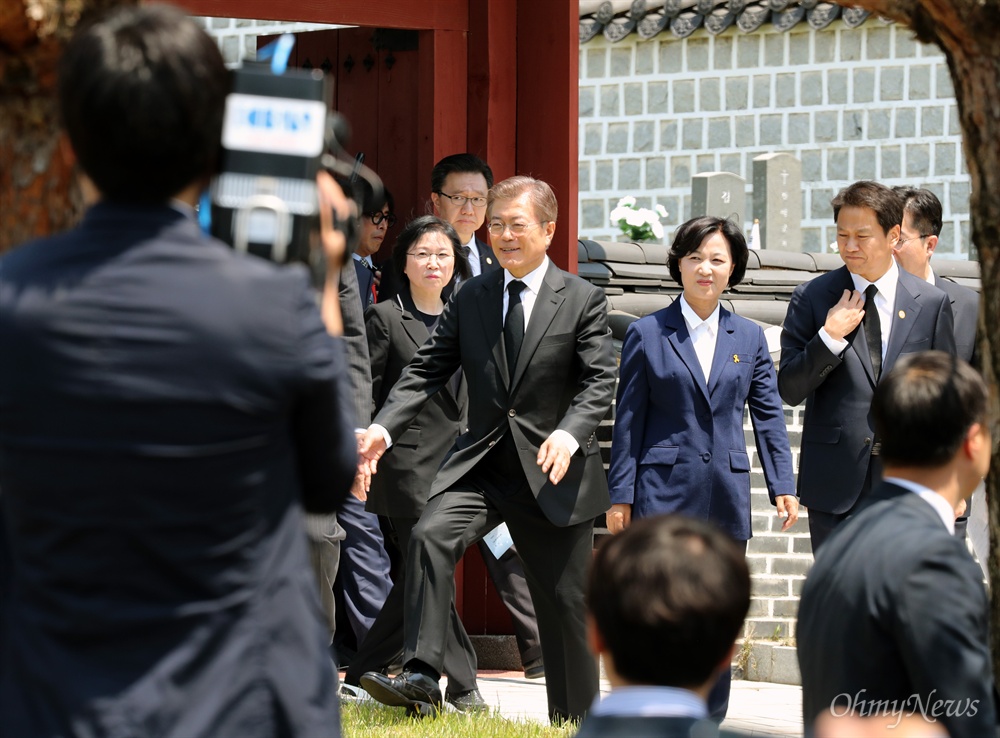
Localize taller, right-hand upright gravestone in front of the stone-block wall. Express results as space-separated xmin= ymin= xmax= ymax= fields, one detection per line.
xmin=753 ymin=154 xmax=802 ymax=252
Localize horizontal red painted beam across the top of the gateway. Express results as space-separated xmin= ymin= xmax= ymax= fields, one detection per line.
xmin=174 ymin=0 xmax=468 ymax=31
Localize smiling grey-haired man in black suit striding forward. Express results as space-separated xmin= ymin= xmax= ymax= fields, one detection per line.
xmin=360 ymin=177 xmax=615 ymax=720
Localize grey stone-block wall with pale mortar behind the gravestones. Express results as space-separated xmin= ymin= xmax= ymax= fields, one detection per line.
xmin=580 ymin=24 xmax=969 ymax=258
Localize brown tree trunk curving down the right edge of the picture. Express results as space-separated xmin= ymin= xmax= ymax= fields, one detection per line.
xmin=845 ymin=0 xmax=1000 ymax=675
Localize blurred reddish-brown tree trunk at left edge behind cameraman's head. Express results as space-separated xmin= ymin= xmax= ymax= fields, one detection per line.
xmin=0 ymin=0 xmax=134 ymax=253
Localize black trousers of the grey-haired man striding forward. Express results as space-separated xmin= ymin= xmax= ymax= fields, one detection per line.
xmin=404 ymin=436 xmax=598 ymax=720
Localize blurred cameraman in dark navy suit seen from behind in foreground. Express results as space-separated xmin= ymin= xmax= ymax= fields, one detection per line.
xmin=0 ymin=6 xmax=356 ymax=738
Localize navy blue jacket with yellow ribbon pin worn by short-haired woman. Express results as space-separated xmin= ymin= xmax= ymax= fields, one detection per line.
xmin=609 ymin=299 xmax=795 ymax=541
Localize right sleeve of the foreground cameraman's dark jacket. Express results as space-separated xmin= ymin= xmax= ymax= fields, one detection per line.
xmin=291 ymin=282 xmax=357 ymax=513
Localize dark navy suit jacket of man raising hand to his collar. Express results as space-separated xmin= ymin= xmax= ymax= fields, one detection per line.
xmin=778 ymin=267 xmax=955 ymax=514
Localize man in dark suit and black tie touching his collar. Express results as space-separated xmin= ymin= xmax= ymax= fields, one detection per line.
xmin=778 ymin=181 xmax=955 ymax=553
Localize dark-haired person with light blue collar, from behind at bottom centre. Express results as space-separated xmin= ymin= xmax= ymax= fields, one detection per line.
xmin=577 ymin=515 xmax=750 ymax=738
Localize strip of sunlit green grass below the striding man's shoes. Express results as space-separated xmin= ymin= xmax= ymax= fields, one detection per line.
xmin=340 ymin=701 xmax=576 ymax=738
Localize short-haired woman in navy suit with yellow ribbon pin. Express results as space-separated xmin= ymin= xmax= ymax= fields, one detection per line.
xmin=608 ymin=216 xmax=798 ymax=718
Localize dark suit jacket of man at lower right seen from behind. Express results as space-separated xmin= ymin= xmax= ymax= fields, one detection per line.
xmin=795 ymin=483 xmax=997 ymax=738
